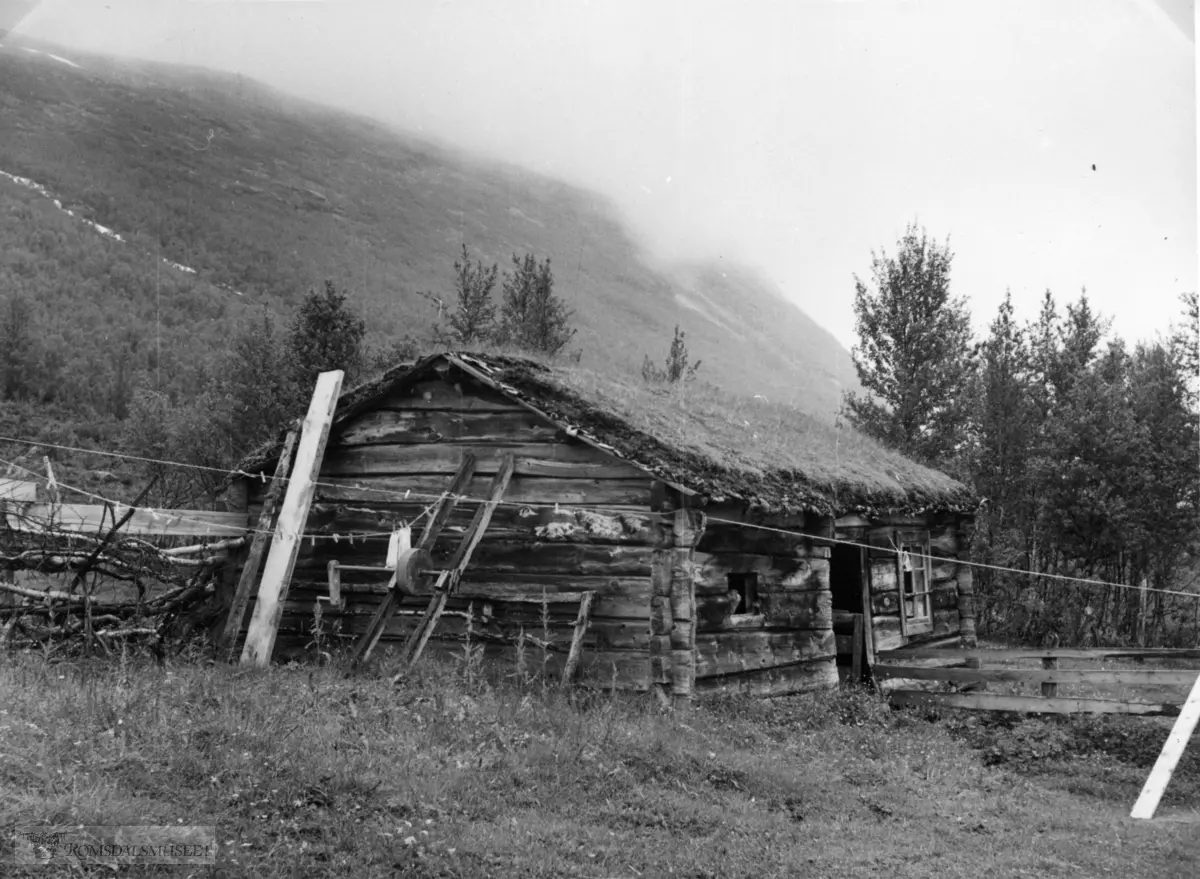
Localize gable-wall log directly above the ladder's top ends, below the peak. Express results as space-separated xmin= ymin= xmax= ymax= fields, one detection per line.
xmin=330 ymin=408 xmax=566 ymax=448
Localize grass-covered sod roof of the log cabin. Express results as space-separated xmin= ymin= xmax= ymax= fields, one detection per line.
xmin=239 ymin=353 xmax=974 ymax=515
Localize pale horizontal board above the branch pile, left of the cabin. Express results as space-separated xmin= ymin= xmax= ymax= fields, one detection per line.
xmin=0 ymin=503 xmax=250 ymax=537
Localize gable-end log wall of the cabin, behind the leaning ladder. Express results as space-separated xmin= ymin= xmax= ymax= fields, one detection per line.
xmin=248 ymin=382 xmax=658 ymax=689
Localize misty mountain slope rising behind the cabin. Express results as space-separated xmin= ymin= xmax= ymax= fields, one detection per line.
xmin=0 ymin=35 xmax=854 ymax=429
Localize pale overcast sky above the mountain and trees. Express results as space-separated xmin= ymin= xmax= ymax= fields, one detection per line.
xmin=11 ymin=0 xmax=1198 ymax=346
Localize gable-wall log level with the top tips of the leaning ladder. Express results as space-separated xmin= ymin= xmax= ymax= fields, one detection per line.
xmin=322 ymin=442 xmax=649 ymax=479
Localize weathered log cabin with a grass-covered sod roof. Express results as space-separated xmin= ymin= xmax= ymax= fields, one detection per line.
xmin=227 ymin=353 xmax=974 ymax=700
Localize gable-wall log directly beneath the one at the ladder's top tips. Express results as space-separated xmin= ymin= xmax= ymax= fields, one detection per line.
xmin=316 ymin=474 xmax=653 ymax=510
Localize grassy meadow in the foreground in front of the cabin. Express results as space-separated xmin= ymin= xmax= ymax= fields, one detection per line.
xmin=0 ymin=653 xmax=1200 ymax=879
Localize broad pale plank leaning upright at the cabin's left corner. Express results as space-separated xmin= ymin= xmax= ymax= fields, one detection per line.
xmin=241 ymin=370 xmax=343 ymax=668
